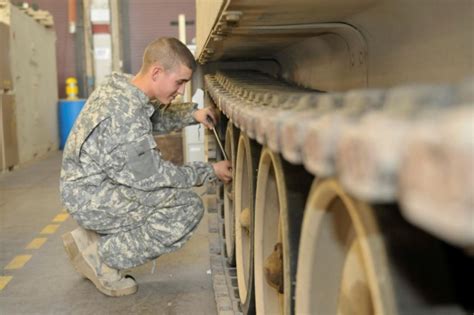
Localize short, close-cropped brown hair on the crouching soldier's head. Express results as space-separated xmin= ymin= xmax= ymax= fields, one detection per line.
xmin=140 ymin=37 xmax=196 ymax=73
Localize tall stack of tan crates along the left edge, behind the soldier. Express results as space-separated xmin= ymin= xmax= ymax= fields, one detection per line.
xmin=0 ymin=0 xmax=59 ymax=171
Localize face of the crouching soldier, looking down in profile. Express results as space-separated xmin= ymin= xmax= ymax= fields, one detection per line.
xmin=153 ymin=64 xmax=193 ymax=104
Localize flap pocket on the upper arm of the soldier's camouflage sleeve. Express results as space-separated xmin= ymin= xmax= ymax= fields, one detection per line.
xmin=127 ymin=136 xmax=156 ymax=180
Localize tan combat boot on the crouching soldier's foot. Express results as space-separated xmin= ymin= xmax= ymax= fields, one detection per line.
xmin=63 ymin=233 xmax=138 ymax=296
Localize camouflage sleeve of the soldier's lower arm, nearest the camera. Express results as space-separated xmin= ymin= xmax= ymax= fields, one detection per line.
xmin=83 ymin=121 xmax=215 ymax=191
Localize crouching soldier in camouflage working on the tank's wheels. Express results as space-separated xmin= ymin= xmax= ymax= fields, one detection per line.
xmin=60 ymin=38 xmax=232 ymax=296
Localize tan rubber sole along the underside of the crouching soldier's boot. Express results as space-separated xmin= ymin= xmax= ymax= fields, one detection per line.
xmin=63 ymin=233 xmax=138 ymax=296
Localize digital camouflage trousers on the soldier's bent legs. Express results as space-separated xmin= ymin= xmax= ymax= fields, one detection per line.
xmin=71 ymin=188 xmax=204 ymax=269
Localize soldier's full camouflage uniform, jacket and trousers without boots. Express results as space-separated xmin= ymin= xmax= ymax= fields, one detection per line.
xmin=60 ymin=73 xmax=215 ymax=269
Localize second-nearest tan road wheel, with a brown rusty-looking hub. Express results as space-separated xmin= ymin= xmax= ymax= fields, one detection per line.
xmin=254 ymin=148 xmax=312 ymax=314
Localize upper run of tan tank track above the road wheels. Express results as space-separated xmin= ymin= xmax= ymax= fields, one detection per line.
xmin=205 ymin=70 xmax=474 ymax=246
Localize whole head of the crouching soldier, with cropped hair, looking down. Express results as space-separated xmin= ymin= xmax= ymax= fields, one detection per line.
xmin=137 ymin=37 xmax=196 ymax=104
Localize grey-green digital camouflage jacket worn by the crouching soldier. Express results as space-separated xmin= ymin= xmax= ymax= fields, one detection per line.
xmin=60 ymin=73 xmax=215 ymax=212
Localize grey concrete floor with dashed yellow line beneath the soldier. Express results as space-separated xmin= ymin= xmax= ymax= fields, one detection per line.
xmin=0 ymin=153 xmax=217 ymax=315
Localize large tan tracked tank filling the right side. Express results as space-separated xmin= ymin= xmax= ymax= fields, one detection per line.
xmin=196 ymin=0 xmax=474 ymax=315
